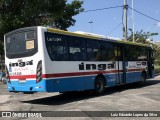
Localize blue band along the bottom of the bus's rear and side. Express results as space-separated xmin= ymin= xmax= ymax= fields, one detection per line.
xmin=7 ymin=72 xmax=145 ymax=92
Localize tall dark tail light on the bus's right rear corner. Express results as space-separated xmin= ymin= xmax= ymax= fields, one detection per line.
xmin=36 ymin=60 xmax=42 ymax=83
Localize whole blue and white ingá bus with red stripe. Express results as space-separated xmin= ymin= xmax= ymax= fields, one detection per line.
xmin=4 ymin=26 xmax=154 ymax=94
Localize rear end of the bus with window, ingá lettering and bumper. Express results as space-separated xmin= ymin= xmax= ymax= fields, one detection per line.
xmin=4 ymin=27 xmax=46 ymax=92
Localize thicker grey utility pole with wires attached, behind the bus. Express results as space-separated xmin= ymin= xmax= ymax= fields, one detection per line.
xmin=123 ymin=0 xmax=128 ymax=41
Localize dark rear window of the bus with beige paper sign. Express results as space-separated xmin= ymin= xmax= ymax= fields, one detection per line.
xmin=5 ymin=30 xmax=37 ymax=58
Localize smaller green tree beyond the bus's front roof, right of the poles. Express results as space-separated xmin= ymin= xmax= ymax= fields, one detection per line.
xmin=128 ymin=29 xmax=158 ymax=44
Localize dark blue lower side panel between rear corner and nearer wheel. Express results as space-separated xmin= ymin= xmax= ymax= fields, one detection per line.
xmin=46 ymin=76 xmax=95 ymax=92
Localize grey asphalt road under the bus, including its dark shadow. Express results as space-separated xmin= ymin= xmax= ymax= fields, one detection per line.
xmin=0 ymin=76 xmax=160 ymax=120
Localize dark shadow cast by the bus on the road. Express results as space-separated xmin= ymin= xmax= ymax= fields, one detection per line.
xmin=21 ymin=80 xmax=160 ymax=105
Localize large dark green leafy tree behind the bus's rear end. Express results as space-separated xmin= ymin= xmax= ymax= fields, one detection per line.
xmin=0 ymin=0 xmax=83 ymax=54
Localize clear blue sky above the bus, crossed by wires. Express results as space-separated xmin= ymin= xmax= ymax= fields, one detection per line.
xmin=68 ymin=0 xmax=160 ymax=42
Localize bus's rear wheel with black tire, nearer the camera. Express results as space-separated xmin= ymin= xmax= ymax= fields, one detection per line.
xmin=94 ymin=76 xmax=105 ymax=95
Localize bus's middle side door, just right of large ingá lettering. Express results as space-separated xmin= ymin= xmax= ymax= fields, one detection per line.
xmin=115 ymin=46 xmax=126 ymax=84
